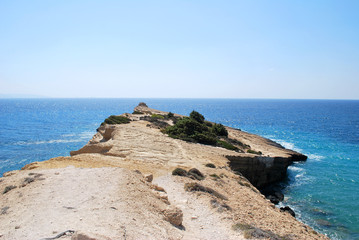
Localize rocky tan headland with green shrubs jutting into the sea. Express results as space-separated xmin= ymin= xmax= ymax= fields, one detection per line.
xmin=0 ymin=103 xmax=328 ymax=240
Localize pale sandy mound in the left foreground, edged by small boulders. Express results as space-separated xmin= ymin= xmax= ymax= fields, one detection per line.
xmin=0 ymin=167 xmax=183 ymax=240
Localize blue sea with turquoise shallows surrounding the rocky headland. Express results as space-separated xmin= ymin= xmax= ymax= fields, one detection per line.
xmin=0 ymin=99 xmax=359 ymax=239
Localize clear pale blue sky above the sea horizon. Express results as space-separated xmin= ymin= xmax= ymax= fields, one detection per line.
xmin=0 ymin=0 xmax=359 ymax=99
